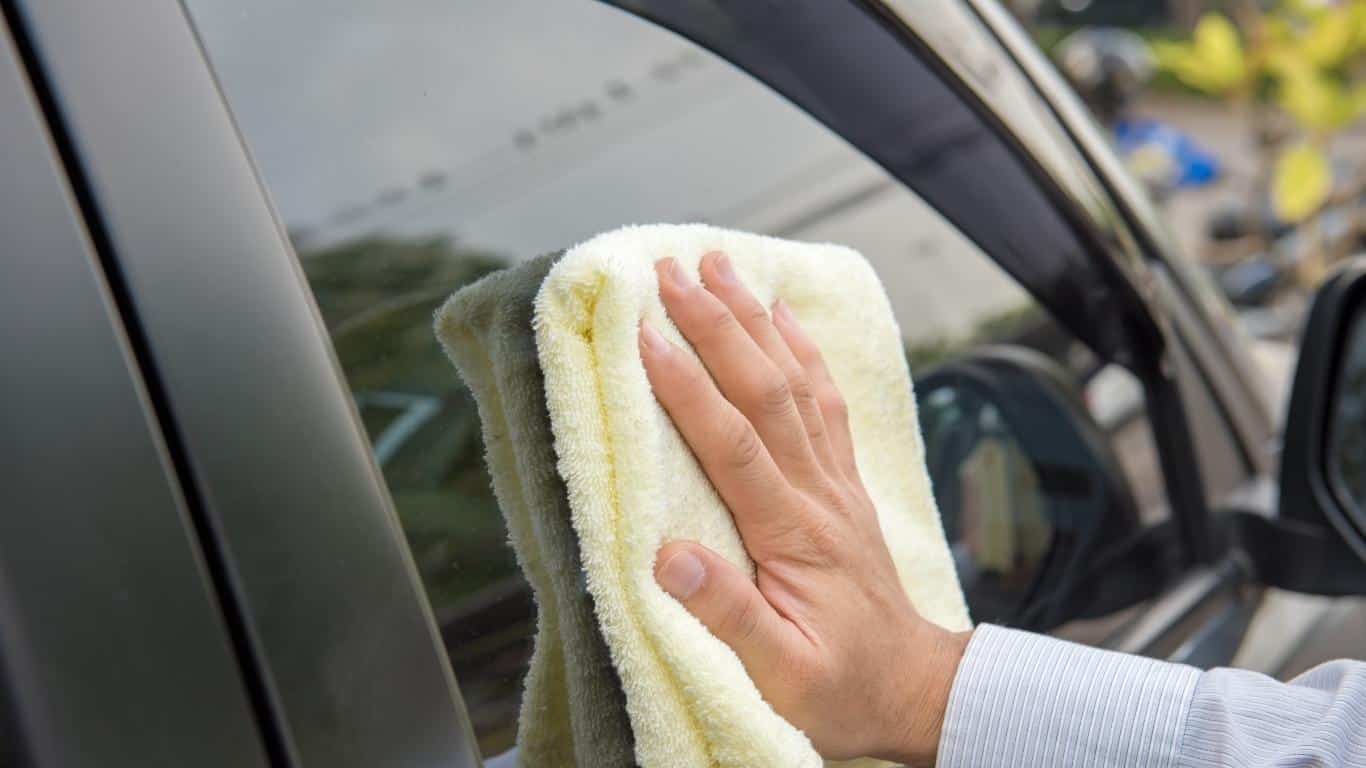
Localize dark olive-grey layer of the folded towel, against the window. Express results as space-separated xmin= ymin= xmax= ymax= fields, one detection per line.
xmin=436 ymin=254 xmax=635 ymax=768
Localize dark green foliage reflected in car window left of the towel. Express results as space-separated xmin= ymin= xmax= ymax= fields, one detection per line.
xmin=298 ymin=236 xmax=535 ymax=754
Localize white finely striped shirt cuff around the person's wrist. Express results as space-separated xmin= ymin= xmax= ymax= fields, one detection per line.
xmin=937 ymin=625 xmax=1201 ymax=768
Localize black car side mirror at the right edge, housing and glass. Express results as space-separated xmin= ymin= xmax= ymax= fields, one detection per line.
xmin=1238 ymin=258 xmax=1366 ymax=594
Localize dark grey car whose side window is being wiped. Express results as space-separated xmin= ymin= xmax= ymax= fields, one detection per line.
xmin=0 ymin=0 xmax=1366 ymax=767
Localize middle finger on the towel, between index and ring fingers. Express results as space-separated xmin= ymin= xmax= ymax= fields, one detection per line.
xmin=656 ymin=258 xmax=820 ymax=481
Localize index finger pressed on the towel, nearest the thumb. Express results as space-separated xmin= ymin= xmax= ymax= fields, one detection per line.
xmin=641 ymin=323 xmax=795 ymax=547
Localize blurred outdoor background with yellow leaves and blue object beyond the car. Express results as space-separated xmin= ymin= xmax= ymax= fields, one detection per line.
xmin=1008 ymin=0 xmax=1366 ymax=340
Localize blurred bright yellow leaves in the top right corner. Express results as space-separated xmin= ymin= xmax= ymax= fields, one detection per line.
xmin=1152 ymin=0 xmax=1366 ymax=223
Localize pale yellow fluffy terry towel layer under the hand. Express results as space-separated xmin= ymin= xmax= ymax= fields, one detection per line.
xmin=535 ymin=224 xmax=970 ymax=768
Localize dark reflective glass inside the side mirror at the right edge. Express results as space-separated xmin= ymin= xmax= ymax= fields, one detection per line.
xmin=1328 ymin=305 xmax=1366 ymax=513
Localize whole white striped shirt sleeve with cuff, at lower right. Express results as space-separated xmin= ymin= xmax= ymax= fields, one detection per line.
xmin=937 ymin=625 xmax=1366 ymax=768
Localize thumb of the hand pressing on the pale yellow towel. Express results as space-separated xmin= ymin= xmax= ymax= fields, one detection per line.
xmin=654 ymin=541 xmax=796 ymax=676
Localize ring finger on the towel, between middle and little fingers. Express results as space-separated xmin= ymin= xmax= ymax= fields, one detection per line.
xmin=701 ymin=251 xmax=835 ymax=470
